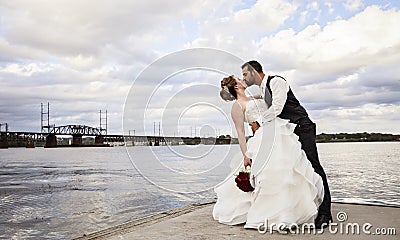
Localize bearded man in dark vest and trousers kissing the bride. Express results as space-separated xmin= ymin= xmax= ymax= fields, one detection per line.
xmin=242 ymin=61 xmax=332 ymax=229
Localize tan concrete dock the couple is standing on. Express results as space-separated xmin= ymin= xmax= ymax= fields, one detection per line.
xmin=77 ymin=203 xmax=400 ymax=240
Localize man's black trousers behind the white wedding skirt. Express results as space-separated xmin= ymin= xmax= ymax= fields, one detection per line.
xmin=294 ymin=117 xmax=331 ymax=215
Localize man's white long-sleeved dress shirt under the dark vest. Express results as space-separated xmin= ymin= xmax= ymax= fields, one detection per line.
xmin=257 ymin=76 xmax=289 ymax=125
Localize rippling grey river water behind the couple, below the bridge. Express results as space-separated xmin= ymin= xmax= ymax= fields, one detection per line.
xmin=0 ymin=142 xmax=400 ymax=239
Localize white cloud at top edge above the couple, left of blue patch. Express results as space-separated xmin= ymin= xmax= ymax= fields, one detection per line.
xmin=186 ymin=0 xmax=298 ymax=56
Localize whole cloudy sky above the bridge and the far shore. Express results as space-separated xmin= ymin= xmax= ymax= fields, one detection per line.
xmin=0 ymin=0 xmax=400 ymax=136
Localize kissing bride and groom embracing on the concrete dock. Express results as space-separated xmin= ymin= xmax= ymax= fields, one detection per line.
xmin=213 ymin=61 xmax=332 ymax=230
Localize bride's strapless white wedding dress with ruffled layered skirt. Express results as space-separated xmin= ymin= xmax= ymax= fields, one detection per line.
xmin=213 ymin=99 xmax=324 ymax=229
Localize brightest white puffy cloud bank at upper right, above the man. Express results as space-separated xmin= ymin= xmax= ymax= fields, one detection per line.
xmin=260 ymin=6 xmax=400 ymax=72
